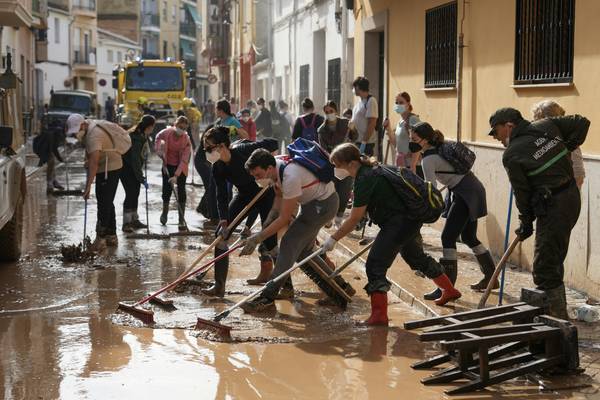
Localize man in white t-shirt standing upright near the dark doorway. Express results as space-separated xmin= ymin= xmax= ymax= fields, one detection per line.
xmin=350 ymin=76 xmax=379 ymax=156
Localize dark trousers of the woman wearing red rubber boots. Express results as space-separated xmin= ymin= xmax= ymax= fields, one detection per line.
xmin=364 ymin=215 xmax=443 ymax=295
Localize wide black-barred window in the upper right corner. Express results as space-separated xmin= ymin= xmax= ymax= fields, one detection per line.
xmin=515 ymin=0 xmax=575 ymax=85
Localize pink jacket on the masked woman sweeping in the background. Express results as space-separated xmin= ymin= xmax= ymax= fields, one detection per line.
xmin=155 ymin=127 xmax=192 ymax=176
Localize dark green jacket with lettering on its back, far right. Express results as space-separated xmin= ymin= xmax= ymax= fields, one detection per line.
xmin=502 ymin=115 xmax=590 ymax=223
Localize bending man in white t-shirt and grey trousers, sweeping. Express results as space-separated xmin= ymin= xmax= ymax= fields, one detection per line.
xmin=240 ymin=149 xmax=339 ymax=312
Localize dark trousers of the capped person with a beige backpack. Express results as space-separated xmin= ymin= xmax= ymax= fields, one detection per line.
xmin=96 ymin=170 xmax=121 ymax=237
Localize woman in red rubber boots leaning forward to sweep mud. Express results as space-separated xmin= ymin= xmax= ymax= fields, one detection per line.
xmin=323 ymin=143 xmax=461 ymax=325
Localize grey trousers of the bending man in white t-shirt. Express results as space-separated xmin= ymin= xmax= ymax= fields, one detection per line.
xmin=262 ymin=193 xmax=339 ymax=300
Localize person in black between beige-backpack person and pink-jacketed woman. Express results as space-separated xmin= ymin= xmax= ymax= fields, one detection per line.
xmin=120 ymin=115 xmax=156 ymax=233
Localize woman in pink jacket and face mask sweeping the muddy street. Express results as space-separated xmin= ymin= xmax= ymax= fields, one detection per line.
xmin=155 ymin=116 xmax=192 ymax=231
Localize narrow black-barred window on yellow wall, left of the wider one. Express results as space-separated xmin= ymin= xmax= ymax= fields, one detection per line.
xmin=425 ymin=1 xmax=457 ymax=88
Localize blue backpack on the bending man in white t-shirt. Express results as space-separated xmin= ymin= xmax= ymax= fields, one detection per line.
xmin=279 ymin=138 xmax=334 ymax=185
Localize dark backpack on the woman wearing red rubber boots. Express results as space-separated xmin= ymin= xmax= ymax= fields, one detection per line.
xmin=372 ymin=165 xmax=445 ymax=224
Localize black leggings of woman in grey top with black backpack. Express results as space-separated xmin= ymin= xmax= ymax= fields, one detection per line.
xmin=442 ymin=194 xmax=481 ymax=249
